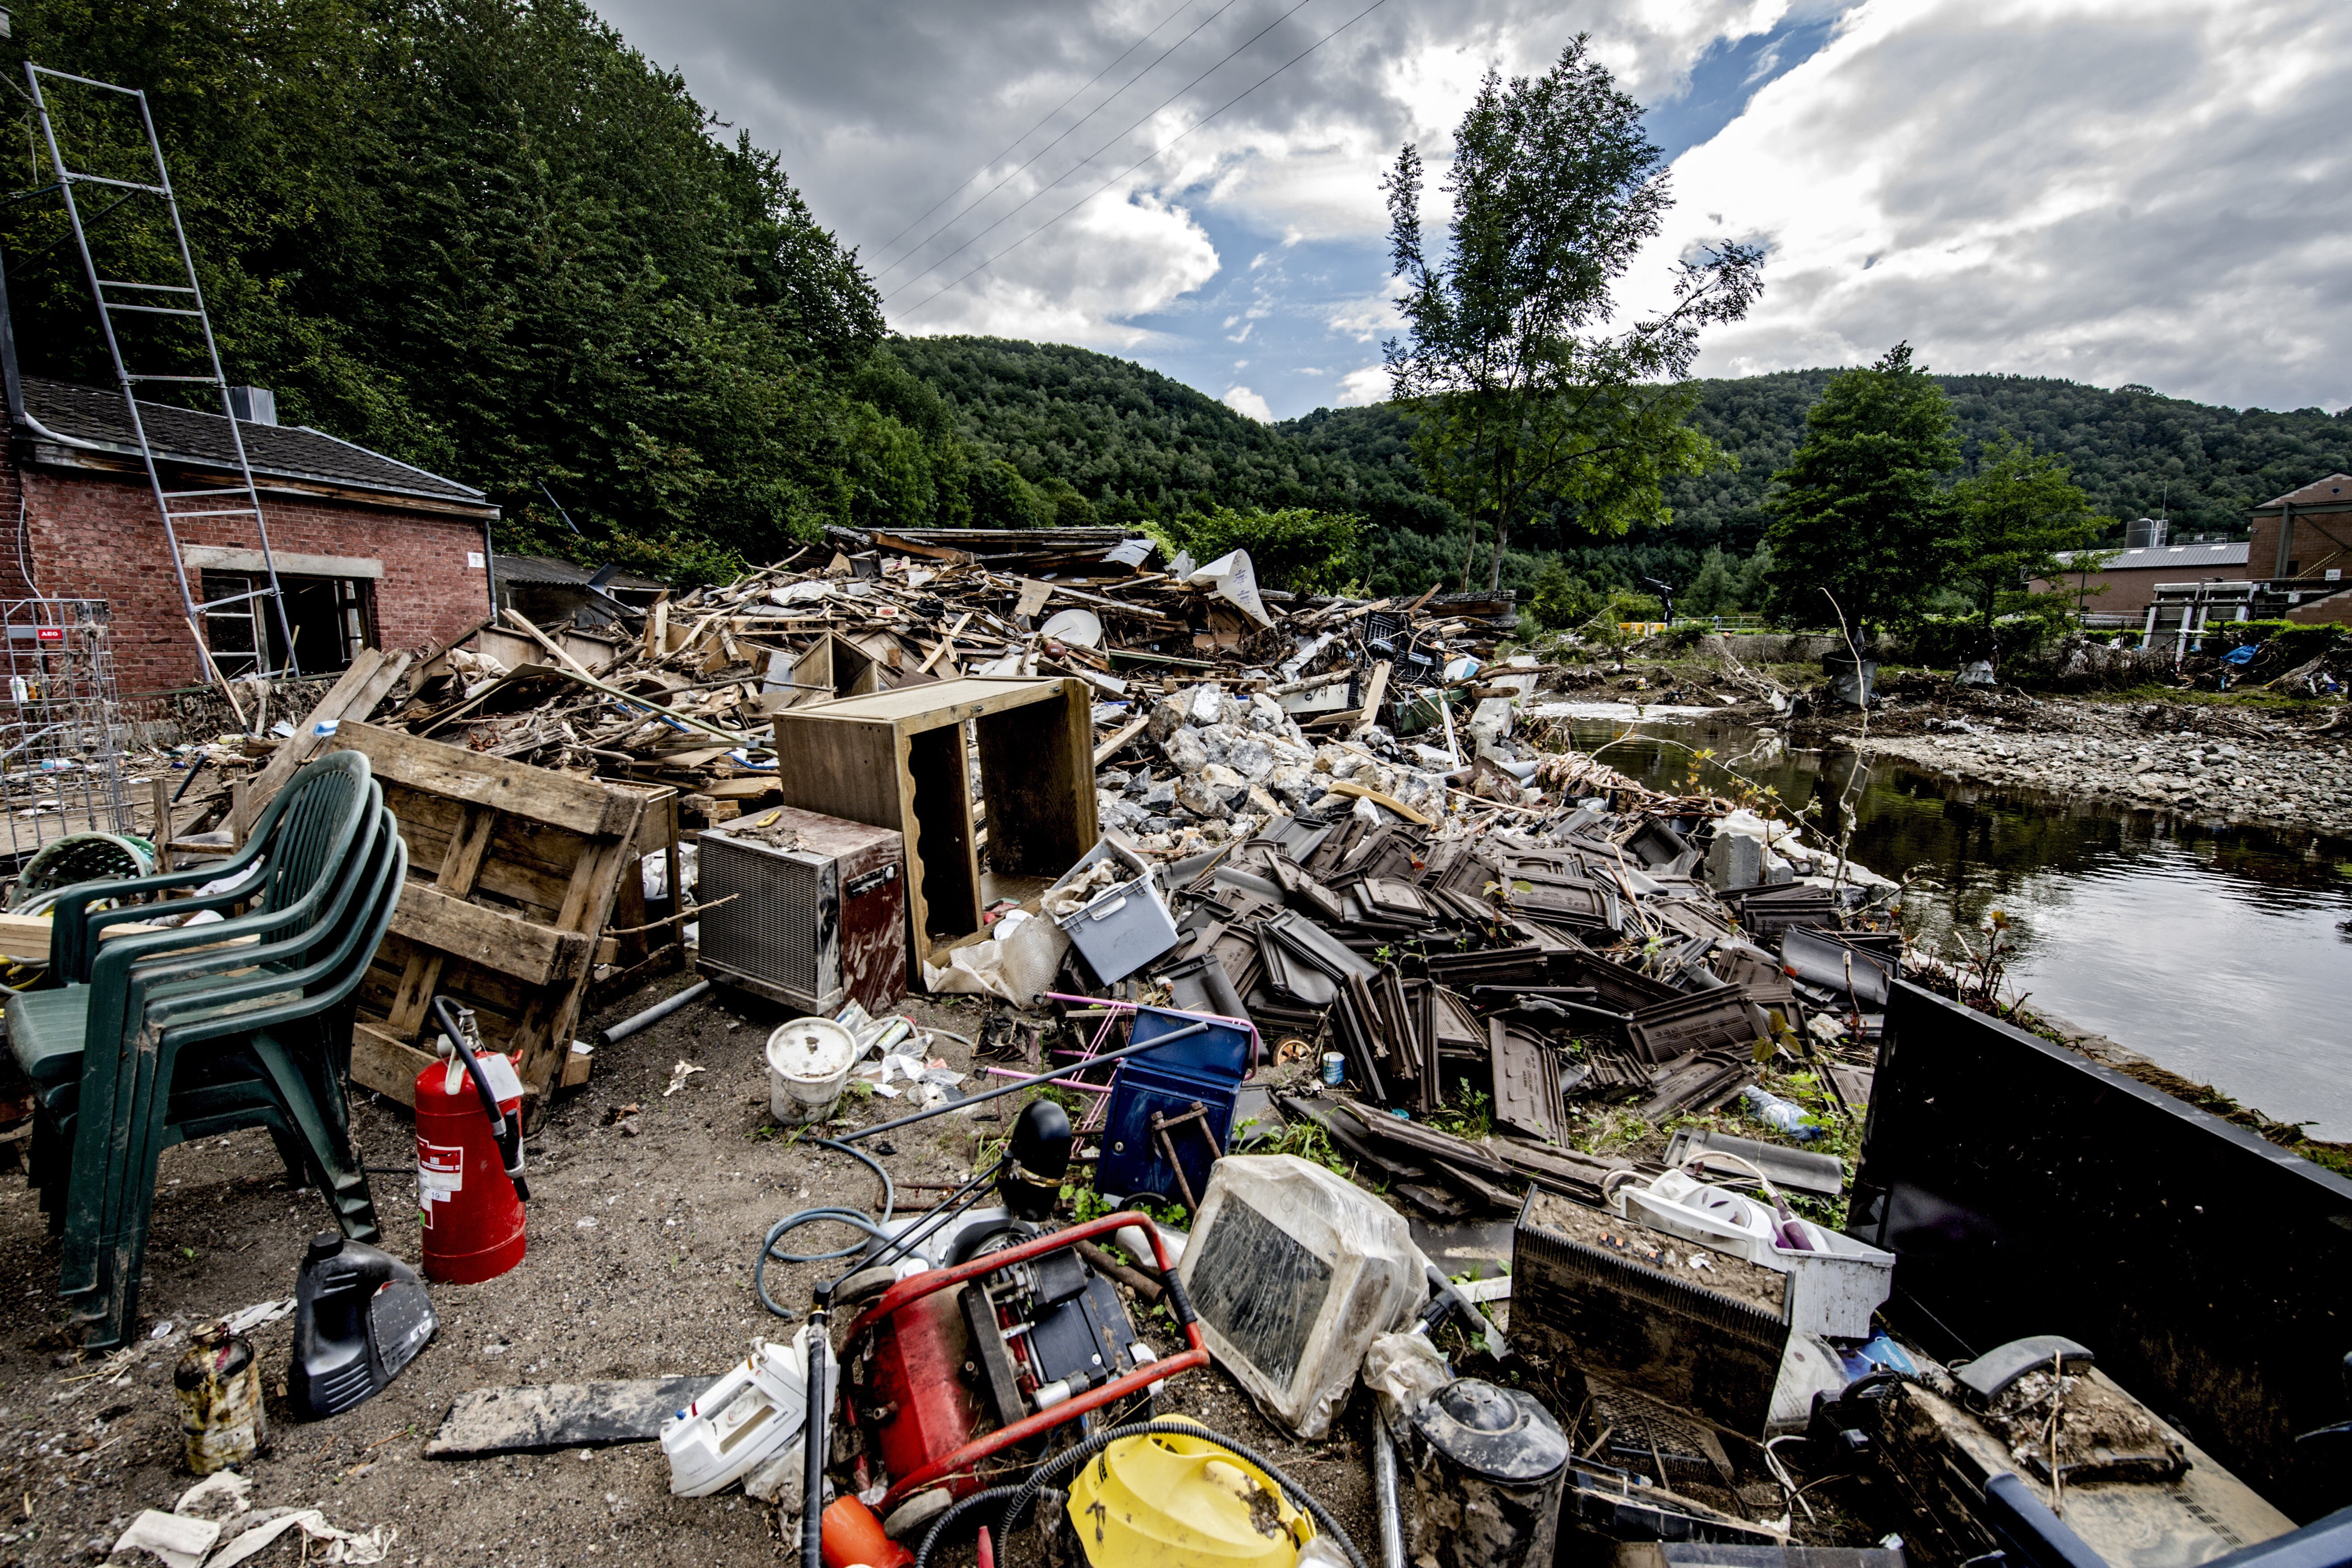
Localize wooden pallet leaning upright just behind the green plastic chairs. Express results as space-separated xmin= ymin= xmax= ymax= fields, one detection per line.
xmin=334 ymin=724 xmax=647 ymax=1124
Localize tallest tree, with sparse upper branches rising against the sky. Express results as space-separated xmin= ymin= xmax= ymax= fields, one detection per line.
xmin=1383 ymin=35 xmax=1762 ymax=585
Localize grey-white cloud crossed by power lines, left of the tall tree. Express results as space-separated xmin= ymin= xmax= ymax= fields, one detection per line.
xmin=593 ymin=0 xmax=1788 ymax=345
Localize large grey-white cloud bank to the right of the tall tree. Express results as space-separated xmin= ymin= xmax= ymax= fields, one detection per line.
xmin=1637 ymin=0 xmax=2352 ymax=409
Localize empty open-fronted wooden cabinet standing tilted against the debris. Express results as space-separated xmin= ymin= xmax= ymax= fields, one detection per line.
xmin=776 ymin=677 xmax=1101 ymax=978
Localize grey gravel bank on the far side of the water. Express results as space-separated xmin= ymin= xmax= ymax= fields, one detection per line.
xmin=1839 ymin=698 xmax=2352 ymax=830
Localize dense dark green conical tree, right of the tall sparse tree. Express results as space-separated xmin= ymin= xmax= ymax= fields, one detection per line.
xmin=1767 ymin=343 xmax=1959 ymax=637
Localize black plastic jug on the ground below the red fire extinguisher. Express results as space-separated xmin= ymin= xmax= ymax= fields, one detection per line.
xmin=287 ymin=1232 xmax=440 ymax=1420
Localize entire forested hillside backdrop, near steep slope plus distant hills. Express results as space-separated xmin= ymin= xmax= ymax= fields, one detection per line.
xmin=0 ymin=0 xmax=2352 ymax=593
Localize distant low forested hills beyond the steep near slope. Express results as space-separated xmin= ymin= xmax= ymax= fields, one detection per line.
xmin=892 ymin=339 xmax=2352 ymax=593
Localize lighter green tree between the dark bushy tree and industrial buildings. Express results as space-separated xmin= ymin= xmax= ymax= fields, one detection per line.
xmin=1952 ymin=430 xmax=2112 ymax=642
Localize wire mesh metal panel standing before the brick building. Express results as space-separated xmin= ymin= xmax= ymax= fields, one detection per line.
xmin=0 ymin=599 xmax=132 ymax=858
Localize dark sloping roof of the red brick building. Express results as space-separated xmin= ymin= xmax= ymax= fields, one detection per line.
xmin=24 ymin=376 xmax=489 ymax=510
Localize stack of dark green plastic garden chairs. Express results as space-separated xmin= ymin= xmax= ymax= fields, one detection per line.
xmin=7 ymin=757 xmax=407 ymax=1347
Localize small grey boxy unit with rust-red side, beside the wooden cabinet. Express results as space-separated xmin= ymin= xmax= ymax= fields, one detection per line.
xmin=696 ymin=806 xmax=908 ymax=1018
